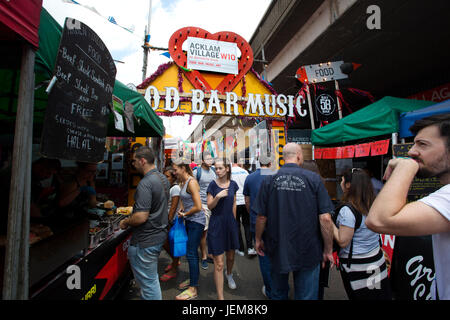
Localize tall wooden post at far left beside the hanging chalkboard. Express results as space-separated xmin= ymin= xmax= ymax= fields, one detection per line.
xmin=3 ymin=44 xmax=35 ymax=300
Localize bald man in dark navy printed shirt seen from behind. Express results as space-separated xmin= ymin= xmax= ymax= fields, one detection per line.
xmin=252 ymin=143 xmax=334 ymax=300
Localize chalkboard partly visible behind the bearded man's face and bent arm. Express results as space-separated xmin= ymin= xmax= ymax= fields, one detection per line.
xmin=392 ymin=143 xmax=442 ymax=196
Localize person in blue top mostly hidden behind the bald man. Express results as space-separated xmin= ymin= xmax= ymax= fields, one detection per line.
xmin=243 ymin=162 xmax=273 ymax=299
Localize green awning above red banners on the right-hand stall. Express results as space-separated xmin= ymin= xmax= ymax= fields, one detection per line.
xmin=311 ymin=96 xmax=434 ymax=145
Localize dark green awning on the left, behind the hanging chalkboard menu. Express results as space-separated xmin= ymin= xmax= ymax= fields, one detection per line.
xmin=0 ymin=8 xmax=164 ymax=137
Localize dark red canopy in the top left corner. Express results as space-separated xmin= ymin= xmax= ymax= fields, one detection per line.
xmin=0 ymin=0 xmax=42 ymax=48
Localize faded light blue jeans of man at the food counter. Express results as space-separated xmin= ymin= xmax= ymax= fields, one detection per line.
xmin=128 ymin=243 xmax=163 ymax=300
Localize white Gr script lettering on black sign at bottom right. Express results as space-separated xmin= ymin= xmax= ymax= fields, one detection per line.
xmin=406 ymin=256 xmax=434 ymax=300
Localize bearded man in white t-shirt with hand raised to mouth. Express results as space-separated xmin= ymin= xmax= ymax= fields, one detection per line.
xmin=366 ymin=114 xmax=450 ymax=300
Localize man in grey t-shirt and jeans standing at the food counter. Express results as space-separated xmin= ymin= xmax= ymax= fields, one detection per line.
xmin=120 ymin=147 xmax=170 ymax=300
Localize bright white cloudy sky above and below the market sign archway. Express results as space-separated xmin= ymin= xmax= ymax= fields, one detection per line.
xmin=43 ymin=0 xmax=271 ymax=139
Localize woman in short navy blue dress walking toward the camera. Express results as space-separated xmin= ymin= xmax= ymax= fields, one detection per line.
xmin=206 ymin=159 xmax=239 ymax=300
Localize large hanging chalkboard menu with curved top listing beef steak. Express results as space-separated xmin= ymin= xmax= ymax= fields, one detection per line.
xmin=40 ymin=18 xmax=116 ymax=163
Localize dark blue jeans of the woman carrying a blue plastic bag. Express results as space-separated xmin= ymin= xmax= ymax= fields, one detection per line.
xmin=185 ymin=220 xmax=205 ymax=287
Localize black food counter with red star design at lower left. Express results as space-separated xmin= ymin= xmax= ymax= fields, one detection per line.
xmin=30 ymin=201 xmax=132 ymax=300
